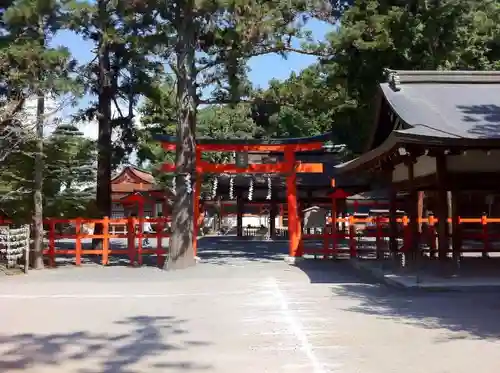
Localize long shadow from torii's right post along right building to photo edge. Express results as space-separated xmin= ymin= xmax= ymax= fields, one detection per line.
xmin=297 ymin=260 xmax=500 ymax=342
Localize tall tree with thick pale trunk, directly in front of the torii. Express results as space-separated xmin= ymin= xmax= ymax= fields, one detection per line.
xmin=146 ymin=0 xmax=331 ymax=269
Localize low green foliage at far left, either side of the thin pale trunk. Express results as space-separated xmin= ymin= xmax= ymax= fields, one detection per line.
xmin=0 ymin=125 xmax=96 ymax=220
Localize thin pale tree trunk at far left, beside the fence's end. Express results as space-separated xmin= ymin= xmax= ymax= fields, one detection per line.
xmin=33 ymin=94 xmax=45 ymax=269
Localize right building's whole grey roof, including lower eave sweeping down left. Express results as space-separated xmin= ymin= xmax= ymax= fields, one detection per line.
xmin=336 ymin=70 xmax=500 ymax=171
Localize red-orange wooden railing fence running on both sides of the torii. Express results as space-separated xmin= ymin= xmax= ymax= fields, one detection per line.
xmin=0 ymin=212 xmax=500 ymax=266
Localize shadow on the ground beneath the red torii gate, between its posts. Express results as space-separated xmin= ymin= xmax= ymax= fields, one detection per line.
xmin=198 ymin=236 xmax=288 ymax=265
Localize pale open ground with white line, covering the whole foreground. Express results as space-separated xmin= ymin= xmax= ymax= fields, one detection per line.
xmin=0 ymin=237 xmax=500 ymax=373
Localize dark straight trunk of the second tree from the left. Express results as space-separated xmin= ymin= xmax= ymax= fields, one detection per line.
xmin=92 ymin=0 xmax=113 ymax=247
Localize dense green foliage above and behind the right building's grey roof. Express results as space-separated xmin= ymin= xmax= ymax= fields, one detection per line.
xmin=253 ymin=0 xmax=500 ymax=153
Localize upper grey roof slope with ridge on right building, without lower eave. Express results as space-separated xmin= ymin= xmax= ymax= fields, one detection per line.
xmin=380 ymin=71 xmax=500 ymax=139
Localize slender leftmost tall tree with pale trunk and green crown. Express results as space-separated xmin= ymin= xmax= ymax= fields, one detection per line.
xmin=4 ymin=0 xmax=78 ymax=269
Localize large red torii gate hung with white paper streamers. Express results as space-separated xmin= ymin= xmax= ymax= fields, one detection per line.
xmin=154 ymin=133 xmax=331 ymax=258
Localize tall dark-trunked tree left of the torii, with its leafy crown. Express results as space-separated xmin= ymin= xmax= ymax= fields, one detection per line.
xmin=68 ymin=0 xmax=161 ymax=244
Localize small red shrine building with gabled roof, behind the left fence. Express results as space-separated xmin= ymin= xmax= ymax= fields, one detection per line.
xmin=111 ymin=165 xmax=168 ymax=219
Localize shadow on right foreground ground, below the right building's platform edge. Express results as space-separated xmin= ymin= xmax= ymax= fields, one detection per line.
xmin=332 ymin=274 xmax=500 ymax=343
